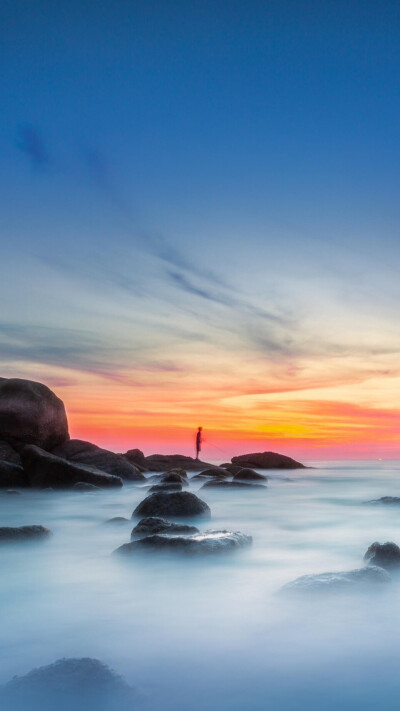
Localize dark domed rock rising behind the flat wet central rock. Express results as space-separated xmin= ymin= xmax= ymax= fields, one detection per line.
xmin=132 ymin=491 xmax=211 ymax=518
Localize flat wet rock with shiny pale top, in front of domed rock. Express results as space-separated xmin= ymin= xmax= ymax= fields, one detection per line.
xmin=114 ymin=531 xmax=252 ymax=555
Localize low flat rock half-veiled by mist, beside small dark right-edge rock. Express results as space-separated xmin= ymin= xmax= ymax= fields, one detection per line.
xmin=281 ymin=566 xmax=391 ymax=593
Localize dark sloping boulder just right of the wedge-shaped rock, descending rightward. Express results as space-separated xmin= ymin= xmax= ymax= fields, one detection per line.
xmin=52 ymin=439 xmax=145 ymax=481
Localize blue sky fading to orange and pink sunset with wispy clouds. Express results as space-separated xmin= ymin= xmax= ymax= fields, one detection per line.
xmin=0 ymin=0 xmax=400 ymax=460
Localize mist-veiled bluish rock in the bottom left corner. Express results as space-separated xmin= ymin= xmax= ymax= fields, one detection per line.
xmin=0 ymin=658 xmax=137 ymax=711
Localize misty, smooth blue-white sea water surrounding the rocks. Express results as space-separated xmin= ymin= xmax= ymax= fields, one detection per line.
xmin=0 ymin=462 xmax=400 ymax=711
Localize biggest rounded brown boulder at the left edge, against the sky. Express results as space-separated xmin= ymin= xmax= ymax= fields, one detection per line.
xmin=0 ymin=378 xmax=69 ymax=451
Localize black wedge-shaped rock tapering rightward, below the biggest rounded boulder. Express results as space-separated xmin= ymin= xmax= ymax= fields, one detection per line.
xmin=21 ymin=445 xmax=122 ymax=489
